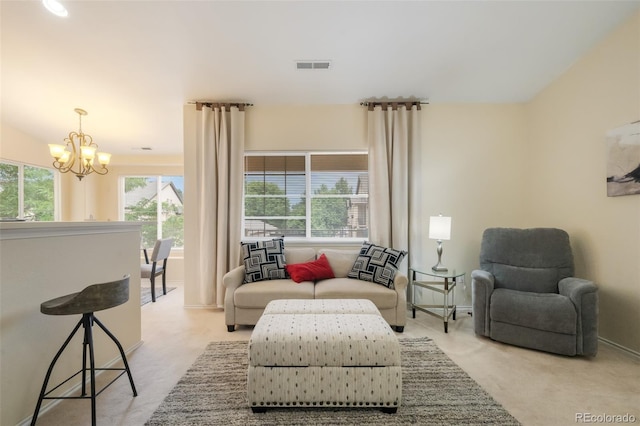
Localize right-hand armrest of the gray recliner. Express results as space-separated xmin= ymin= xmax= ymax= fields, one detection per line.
xmin=558 ymin=277 xmax=598 ymax=356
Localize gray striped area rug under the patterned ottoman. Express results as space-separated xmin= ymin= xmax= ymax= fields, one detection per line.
xmin=146 ymin=338 xmax=519 ymax=426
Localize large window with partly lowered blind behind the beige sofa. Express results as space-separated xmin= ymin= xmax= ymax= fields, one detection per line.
xmin=243 ymin=153 xmax=369 ymax=239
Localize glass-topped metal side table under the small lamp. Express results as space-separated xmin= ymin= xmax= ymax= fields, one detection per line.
xmin=409 ymin=267 xmax=465 ymax=333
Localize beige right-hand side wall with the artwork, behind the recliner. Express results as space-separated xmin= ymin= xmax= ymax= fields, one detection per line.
xmin=524 ymin=14 xmax=640 ymax=352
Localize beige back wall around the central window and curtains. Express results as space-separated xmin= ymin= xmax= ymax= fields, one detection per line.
xmin=185 ymin=104 xmax=526 ymax=306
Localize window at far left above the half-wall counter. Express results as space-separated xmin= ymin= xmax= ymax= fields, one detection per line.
xmin=0 ymin=162 xmax=57 ymax=221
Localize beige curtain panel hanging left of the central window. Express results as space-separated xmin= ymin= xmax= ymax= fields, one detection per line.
xmin=190 ymin=104 xmax=245 ymax=307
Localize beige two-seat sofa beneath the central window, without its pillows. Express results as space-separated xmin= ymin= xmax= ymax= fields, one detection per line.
xmin=223 ymin=247 xmax=408 ymax=333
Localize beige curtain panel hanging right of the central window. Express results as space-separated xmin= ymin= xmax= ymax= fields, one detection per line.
xmin=367 ymin=103 xmax=420 ymax=262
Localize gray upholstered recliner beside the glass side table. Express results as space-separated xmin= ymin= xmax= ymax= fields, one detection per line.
xmin=471 ymin=228 xmax=598 ymax=356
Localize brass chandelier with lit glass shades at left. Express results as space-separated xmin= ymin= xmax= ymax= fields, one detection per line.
xmin=49 ymin=108 xmax=111 ymax=180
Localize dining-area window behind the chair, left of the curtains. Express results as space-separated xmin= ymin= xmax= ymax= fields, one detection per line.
xmin=120 ymin=176 xmax=184 ymax=248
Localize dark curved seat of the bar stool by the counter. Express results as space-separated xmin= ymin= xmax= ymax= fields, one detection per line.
xmin=40 ymin=277 xmax=129 ymax=315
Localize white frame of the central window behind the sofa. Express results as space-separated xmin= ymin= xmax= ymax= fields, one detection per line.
xmin=241 ymin=150 xmax=370 ymax=246
